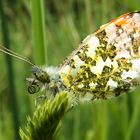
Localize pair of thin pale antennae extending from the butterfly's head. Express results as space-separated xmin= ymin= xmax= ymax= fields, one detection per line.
xmin=0 ymin=46 xmax=35 ymax=66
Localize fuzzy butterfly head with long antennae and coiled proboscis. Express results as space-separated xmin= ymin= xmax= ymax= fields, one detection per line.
xmin=0 ymin=45 xmax=59 ymax=94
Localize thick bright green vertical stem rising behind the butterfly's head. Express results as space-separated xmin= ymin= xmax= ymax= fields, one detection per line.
xmin=31 ymin=0 xmax=47 ymax=65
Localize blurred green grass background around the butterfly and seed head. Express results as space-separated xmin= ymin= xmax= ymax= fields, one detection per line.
xmin=0 ymin=0 xmax=140 ymax=140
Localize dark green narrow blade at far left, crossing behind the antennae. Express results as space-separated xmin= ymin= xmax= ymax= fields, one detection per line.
xmin=0 ymin=0 xmax=19 ymax=140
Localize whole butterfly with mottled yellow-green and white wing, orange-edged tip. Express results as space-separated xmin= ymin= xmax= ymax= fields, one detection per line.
xmin=0 ymin=11 xmax=140 ymax=100
